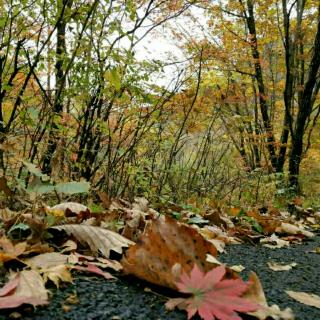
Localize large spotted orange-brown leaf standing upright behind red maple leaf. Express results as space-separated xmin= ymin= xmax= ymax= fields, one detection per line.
xmin=121 ymin=217 xmax=217 ymax=289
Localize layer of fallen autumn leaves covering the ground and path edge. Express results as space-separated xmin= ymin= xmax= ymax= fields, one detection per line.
xmin=0 ymin=193 xmax=320 ymax=320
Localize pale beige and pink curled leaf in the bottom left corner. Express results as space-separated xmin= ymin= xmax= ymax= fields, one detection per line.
xmin=0 ymin=270 xmax=48 ymax=309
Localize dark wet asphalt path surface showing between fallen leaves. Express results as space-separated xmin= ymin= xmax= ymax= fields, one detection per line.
xmin=0 ymin=236 xmax=320 ymax=320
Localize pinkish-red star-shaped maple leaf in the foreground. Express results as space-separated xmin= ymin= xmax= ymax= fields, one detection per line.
xmin=166 ymin=264 xmax=259 ymax=320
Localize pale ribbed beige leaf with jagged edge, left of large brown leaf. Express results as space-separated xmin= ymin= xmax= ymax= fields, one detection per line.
xmin=53 ymin=224 xmax=134 ymax=258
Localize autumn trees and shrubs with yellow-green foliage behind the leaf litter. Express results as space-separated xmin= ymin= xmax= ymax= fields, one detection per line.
xmin=0 ymin=0 xmax=320 ymax=210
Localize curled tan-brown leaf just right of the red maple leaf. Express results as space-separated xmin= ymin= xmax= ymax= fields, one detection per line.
xmin=243 ymin=272 xmax=294 ymax=320
